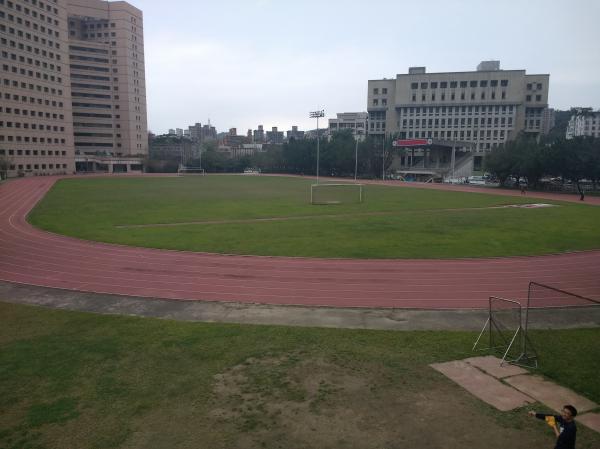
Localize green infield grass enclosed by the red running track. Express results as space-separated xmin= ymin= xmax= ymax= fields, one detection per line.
xmin=29 ymin=176 xmax=600 ymax=258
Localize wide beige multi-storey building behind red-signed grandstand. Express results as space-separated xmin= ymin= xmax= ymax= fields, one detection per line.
xmin=367 ymin=61 xmax=550 ymax=166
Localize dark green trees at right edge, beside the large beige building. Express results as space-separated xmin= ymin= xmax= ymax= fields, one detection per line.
xmin=484 ymin=135 xmax=600 ymax=193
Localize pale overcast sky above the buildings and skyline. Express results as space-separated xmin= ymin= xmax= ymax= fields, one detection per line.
xmin=139 ymin=0 xmax=600 ymax=134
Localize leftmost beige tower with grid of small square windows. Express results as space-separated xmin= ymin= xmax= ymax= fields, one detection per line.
xmin=0 ymin=0 xmax=75 ymax=177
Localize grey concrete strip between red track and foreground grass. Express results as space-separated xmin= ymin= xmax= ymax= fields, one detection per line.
xmin=0 ymin=281 xmax=600 ymax=330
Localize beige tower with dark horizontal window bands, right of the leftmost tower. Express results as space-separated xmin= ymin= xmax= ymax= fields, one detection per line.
xmin=67 ymin=0 xmax=148 ymax=161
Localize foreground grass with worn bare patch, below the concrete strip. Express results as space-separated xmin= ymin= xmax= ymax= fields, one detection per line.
xmin=0 ymin=302 xmax=600 ymax=449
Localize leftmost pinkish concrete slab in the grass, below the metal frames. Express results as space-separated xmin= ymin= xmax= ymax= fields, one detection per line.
xmin=430 ymin=360 xmax=535 ymax=411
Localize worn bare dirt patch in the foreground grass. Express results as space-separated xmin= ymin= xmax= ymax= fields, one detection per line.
xmin=210 ymin=355 xmax=552 ymax=449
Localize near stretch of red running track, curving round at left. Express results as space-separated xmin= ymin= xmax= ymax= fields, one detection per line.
xmin=0 ymin=177 xmax=600 ymax=309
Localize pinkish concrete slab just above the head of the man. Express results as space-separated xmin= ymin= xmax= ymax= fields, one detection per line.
xmin=504 ymin=376 xmax=598 ymax=413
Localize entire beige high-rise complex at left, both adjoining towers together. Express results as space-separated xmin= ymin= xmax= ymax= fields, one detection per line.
xmin=0 ymin=0 xmax=148 ymax=176
